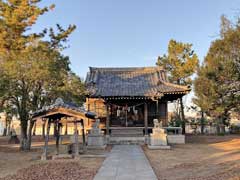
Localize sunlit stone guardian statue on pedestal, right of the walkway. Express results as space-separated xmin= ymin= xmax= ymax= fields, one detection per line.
xmin=148 ymin=119 xmax=170 ymax=149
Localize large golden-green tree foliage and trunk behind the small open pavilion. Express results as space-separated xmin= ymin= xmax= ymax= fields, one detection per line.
xmin=0 ymin=0 xmax=84 ymax=150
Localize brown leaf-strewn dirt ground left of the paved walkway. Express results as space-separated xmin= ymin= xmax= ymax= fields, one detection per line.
xmin=0 ymin=137 xmax=106 ymax=180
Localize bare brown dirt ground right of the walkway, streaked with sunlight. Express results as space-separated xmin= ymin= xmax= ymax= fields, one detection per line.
xmin=143 ymin=135 xmax=240 ymax=180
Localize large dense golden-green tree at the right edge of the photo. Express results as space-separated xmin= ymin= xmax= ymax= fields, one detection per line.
xmin=194 ymin=16 xmax=240 ymax=131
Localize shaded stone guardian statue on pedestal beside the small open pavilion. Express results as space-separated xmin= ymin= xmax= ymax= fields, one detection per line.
xmin=87 ymin=119 xmax=106 ymax=149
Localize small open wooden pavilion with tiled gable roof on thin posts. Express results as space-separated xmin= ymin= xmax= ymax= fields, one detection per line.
xmin=33 ymin=98 xmax=95 ymax=160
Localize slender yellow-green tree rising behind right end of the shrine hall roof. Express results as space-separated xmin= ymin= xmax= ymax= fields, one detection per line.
xmin=157 ymin=40 xmax=198 ymax=134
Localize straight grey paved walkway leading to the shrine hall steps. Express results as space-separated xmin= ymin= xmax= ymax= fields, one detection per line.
xmin=94 ymin=145 xmax=157 ymax=180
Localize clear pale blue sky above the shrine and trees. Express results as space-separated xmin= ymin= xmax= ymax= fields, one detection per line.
xmin=33 ymin=0 xmax=240 ymax=77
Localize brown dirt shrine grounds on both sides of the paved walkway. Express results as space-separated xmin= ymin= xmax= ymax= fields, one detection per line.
xmin=0 ymin=135 xmax=240 ymax=180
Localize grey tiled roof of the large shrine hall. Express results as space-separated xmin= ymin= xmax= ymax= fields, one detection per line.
xmin=86 ymin=67 xmax=190 ymax=97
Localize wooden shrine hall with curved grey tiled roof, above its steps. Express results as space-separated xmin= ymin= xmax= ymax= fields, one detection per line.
xmin=86 ymin=67 xmax=190 ymax=135
